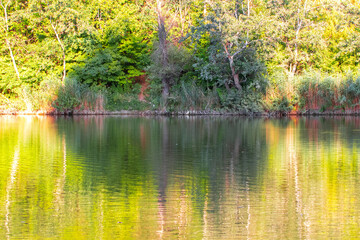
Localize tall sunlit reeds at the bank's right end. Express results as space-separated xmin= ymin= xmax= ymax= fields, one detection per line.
xmin=265 ymin=71 xmax=360 ymax=111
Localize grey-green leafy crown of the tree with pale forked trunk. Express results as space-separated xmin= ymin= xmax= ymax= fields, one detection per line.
xmin=188 ymin=6 xmax=265 ymax=90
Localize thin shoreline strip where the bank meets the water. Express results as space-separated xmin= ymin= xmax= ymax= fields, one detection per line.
xmin=0 ymin=110 xmax=360 ymax=117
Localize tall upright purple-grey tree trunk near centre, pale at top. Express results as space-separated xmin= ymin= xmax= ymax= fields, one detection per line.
xmin=156 ymin=0 xmax=170 ymax=103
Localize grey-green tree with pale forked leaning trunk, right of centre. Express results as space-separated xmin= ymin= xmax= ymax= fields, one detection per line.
xmin=188 ymin=2 xmax=264 ymax=92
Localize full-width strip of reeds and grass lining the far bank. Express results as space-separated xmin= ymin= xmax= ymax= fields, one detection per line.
xmin=0 ymin=72 xmax=360 ymax=115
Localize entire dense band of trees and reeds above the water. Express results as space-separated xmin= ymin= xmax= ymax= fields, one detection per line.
xmin=0 ymin=0 xmax=360 ymax=111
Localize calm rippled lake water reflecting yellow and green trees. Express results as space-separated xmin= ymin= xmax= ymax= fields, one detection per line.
xmin=0 ymin=116 xmax=360 ymax=239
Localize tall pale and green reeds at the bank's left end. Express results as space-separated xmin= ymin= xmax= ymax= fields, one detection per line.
xmin=0 ymin=77 xmax=107 ymax=112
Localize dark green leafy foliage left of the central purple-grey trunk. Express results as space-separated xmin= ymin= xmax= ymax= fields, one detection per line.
xmin=71 ymin=22 xmax=149 ymax=88
